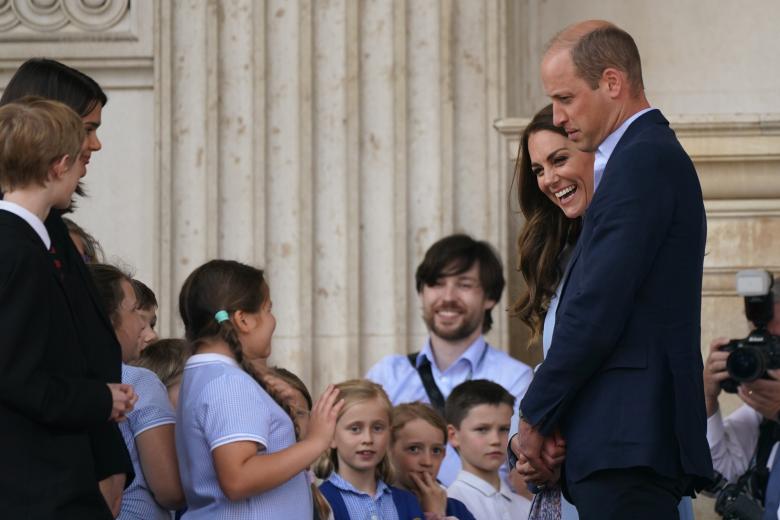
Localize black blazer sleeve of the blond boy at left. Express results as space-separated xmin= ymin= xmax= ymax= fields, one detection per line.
xmin=0 ymin=246 xmax=112 ymax=430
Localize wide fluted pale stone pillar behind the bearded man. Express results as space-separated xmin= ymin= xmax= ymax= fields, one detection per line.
xmin=160 ymin=0 xmax=506 ymax=390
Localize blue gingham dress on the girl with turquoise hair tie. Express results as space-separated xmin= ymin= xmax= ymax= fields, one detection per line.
xmin=176 ymin=354 xmax=313 ymax=520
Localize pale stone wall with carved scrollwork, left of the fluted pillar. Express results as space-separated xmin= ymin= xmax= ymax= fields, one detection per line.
xmin=0 ymin=0 xmax=159 ymax=302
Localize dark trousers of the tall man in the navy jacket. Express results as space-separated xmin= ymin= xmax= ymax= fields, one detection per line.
xmin=566 ymin=468 xmax=688 ymax=520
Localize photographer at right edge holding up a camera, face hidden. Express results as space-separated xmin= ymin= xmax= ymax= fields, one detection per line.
xmin=704 ymin=278 xmax=780 ymax=520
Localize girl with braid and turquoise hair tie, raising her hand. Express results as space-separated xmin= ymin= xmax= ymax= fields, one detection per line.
xmin=176 ymin=260 xmax=343 ymax=520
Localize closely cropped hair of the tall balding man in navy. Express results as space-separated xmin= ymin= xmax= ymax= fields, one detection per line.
xmin=548 ymin=20 xmax=645 ymax=96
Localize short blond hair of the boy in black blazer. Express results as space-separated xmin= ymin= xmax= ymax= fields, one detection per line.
xmin=0 ymin=97 xmax=86 ymax=192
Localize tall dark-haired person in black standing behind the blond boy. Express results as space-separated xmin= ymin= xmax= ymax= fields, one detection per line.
xmin=0 ymin=58 xmax=135 ymax=516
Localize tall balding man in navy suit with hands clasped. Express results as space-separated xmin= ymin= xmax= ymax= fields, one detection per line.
xmin=512 ymin=21 xmax=712 ymax=520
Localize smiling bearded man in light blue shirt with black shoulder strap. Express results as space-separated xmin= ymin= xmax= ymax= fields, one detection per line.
xmin=366 ymin=234 xmax=533 ymax=486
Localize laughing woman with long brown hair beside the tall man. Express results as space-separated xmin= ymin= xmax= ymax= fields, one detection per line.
xmin=511 ymin=105 xmax=693 ymax=520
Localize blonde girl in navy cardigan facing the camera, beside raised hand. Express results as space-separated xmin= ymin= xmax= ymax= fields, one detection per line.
xmin=315 ymin=379 xmax=423 ymax=520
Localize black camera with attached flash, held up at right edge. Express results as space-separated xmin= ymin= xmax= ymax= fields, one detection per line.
xmin=721 ymin=270 xmax=780 ymax=393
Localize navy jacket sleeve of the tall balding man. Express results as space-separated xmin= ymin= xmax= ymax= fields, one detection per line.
xmin=520 ymin=141 xmax=690 ymax=435
